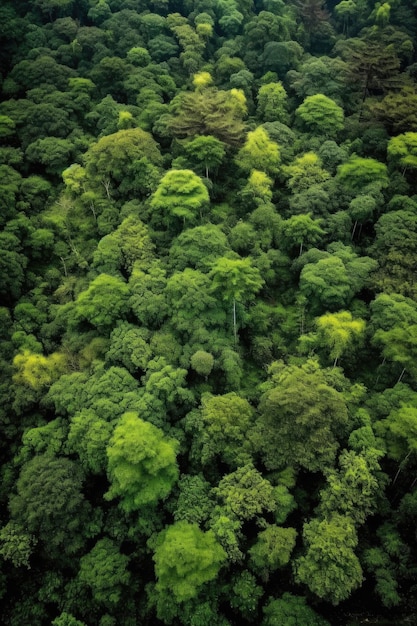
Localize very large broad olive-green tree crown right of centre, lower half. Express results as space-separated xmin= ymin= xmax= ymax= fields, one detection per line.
xmin=255 ymin=359 xmax=349 ymax=472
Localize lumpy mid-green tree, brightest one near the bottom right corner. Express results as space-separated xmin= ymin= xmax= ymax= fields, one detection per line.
xmin=294 ymin=514 xmax=363 ymax=605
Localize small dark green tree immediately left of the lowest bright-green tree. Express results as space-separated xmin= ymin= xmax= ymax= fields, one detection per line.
xmin=78 ymin=537 xmax=130 ymax=607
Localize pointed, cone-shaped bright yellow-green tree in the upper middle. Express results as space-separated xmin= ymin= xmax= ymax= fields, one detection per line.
xmin=235 ymin=126 xmax=281 ymax=175
